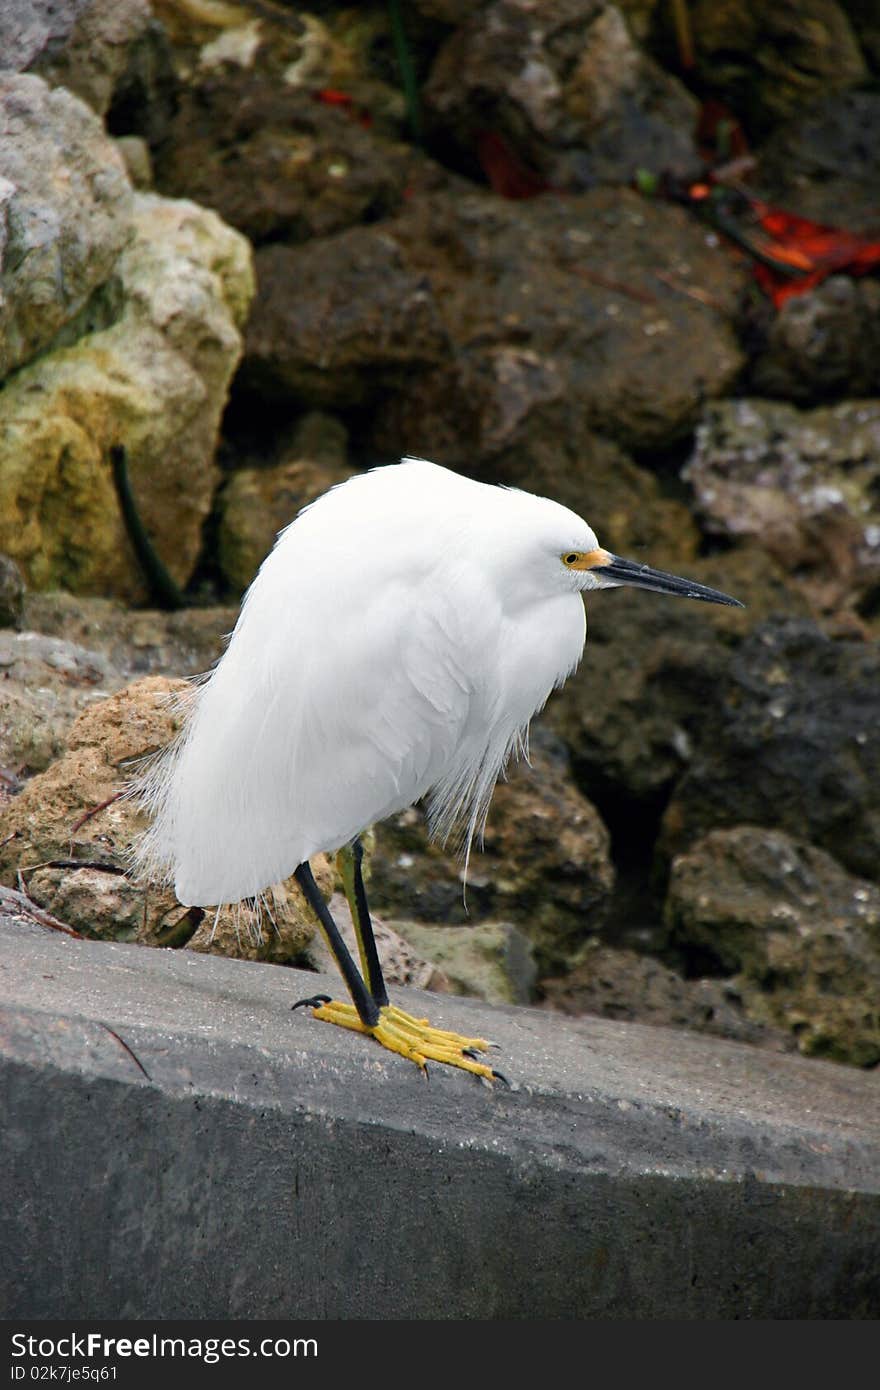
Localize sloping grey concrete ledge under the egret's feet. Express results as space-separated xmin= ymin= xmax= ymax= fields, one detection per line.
xmin=0 ymin=919 xmax=880 ymax=1319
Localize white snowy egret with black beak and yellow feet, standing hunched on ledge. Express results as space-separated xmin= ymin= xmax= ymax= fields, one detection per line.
xmin=136 ymin=459 xmax=741 ymax=1077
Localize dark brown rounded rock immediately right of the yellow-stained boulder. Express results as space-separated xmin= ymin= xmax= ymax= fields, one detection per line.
xmin=241 ymin=227 xmax=448 ymax=407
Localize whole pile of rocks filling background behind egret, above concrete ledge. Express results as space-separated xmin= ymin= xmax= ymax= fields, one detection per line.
xmin=0 ymin=0 xmax=880 ymax=1066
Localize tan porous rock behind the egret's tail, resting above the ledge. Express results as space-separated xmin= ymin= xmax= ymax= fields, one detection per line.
xmin=0 ymin=676 xmax=332 ymax=960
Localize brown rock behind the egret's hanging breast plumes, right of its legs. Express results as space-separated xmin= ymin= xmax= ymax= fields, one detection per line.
xmin=370 ymin=728 xmax=614 ymax=970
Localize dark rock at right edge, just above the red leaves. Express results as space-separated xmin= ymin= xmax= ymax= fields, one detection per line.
xmin=756 ymin=90 xmax=880 ymax=235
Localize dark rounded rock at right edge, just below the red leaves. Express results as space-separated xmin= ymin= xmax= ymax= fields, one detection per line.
xmin=751 ymin=275 xmax=880 ymax=404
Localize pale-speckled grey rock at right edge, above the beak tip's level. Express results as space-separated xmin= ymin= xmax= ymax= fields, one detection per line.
xmin=683 ymin=399 xmax=880 ymax=613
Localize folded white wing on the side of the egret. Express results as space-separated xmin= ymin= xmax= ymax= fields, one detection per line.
xmin=145 ymin=556 xmax=491 ymax=906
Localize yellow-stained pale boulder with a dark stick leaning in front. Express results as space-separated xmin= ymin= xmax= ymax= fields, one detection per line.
xmin=0 ymin=189 xmax=253 ymax=599
